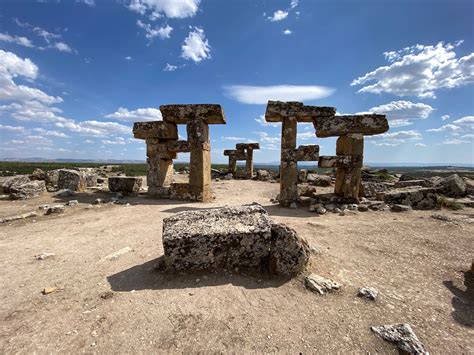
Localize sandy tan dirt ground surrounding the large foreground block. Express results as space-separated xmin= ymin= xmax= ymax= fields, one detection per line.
xmin=0 ymin=181 xmax=474 ymax=354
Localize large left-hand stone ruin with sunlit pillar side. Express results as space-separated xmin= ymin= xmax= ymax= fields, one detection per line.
xmin=133 ymin=104 xmax=226 ymax=202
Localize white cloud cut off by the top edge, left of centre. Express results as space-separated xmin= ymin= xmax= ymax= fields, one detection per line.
xmin=128 ymin=0 xmax=201 ymax=18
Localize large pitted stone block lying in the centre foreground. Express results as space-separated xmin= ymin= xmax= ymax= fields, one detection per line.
xmin=163 ymin=205 xmax=310 ymax=275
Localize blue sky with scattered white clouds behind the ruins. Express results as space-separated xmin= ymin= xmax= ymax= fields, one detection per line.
xmin=0 ymin=0 xmax=474 ymax=165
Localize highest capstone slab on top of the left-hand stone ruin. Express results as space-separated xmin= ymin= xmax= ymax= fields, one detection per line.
xmin=160 ymin=104 xmax=226 ymax=124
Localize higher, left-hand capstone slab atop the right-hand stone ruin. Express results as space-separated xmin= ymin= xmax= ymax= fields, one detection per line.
xmin=265 ymin=101 xmax=336 ymax=122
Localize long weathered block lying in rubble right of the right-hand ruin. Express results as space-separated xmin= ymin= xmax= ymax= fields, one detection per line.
xmin=383 ymin=187 xmax=437 ymax=210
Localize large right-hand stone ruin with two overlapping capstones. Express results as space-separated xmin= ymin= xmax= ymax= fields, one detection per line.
xmin=265 ymin=101 xmax=389 ymax=207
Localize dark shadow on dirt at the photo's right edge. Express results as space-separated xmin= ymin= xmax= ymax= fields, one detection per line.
xmin=443 ymin=271 xmax=474 ymax=328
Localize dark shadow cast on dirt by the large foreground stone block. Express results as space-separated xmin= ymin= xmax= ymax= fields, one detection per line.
xmin=107 ymin=256 xmax=289 ymax=292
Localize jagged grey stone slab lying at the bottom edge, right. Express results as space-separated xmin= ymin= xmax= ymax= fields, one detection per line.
xmin=370 ymin=323 xmax=429 ymax=355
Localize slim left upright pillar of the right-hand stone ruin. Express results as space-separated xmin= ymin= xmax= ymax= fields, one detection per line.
xmin=280 ymin=117 xmax=298 ymax=206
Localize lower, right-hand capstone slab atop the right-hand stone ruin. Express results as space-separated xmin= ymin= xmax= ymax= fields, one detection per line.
xmin=313 ymin=114 xmax=388 ymax=138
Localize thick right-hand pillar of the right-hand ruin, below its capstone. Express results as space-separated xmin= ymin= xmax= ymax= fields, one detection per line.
xmin=334 ymin=134 xmax=364 ymax=200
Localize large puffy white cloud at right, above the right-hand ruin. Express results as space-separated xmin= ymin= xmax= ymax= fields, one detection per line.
xmin=351 ymin=41 xmax=474 ymax=98
